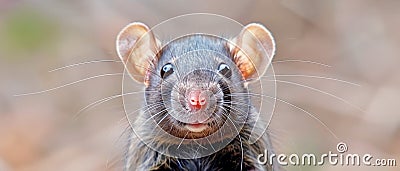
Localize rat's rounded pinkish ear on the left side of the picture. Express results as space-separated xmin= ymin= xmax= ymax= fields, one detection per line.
xmin=116 ymin=22 xmax=160 ymax=85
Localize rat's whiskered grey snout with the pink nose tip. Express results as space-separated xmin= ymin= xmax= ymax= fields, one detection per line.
xmin=164 ymin=70 xmax=223 ymax=126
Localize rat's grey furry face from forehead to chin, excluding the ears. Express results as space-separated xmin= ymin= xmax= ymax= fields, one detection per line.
xmin=146 ymin=35 xmax=249 ymax=138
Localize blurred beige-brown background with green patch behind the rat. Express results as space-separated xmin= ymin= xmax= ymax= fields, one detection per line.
xmin=0 ymin=0 xmax=400 ymax=171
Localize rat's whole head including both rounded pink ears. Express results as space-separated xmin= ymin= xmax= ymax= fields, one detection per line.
xmin=117 ymin=23 xmax=275 ymax=139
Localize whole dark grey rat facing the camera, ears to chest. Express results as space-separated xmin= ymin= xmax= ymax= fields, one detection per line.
xmin=116 ymin=22 xmax=275 ymax=171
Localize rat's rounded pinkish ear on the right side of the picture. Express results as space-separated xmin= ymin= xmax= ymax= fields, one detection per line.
xmin=229 ymin=23 xmax=275 ymax=80
